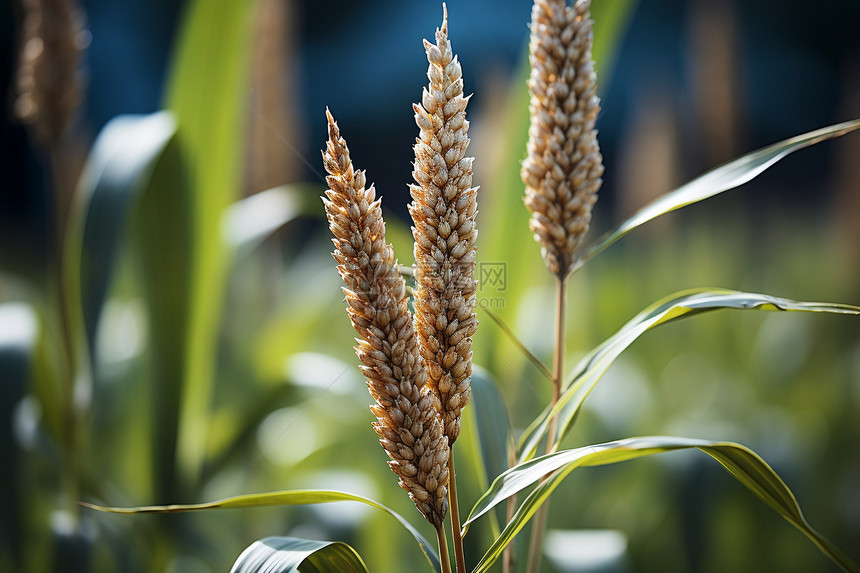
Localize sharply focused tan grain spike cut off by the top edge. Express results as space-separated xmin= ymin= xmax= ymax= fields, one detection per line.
xmin=521 ymin=0 xmax=603 ymax=278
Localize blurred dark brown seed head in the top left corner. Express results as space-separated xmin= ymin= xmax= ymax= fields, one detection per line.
xmin=14 ymin=0 xmax=88 ymax=144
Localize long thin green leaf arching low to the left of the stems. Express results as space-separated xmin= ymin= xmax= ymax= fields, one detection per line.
xmin=81 ymin=489 xmax=442 ymax=572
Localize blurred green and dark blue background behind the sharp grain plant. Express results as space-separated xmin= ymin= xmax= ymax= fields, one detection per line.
xmin=0 ymin=0 xmax=860 ymax=573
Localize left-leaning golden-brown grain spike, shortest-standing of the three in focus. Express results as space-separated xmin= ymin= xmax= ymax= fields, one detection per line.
xmin=323 ymin=110 xmax=450 ymax=527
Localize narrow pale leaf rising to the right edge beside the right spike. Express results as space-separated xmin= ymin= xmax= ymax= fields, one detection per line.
xmin=577 ymin=119 xmax=860 ymax=268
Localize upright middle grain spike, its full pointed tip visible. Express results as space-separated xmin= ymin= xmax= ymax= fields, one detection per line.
xmin=409 ymin=6 xmax=478 ymax=444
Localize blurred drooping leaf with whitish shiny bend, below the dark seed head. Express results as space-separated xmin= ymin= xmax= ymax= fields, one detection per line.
xmin=67 ymin=112 xmax=176 ymax=351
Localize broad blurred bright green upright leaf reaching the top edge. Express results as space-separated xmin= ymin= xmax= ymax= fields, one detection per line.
xmin=164 ymin=0 xmax=258 ymax=484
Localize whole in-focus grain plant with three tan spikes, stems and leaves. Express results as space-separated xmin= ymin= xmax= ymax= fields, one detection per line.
xmin=65 ymin=0 xmax=860 ymax=573
